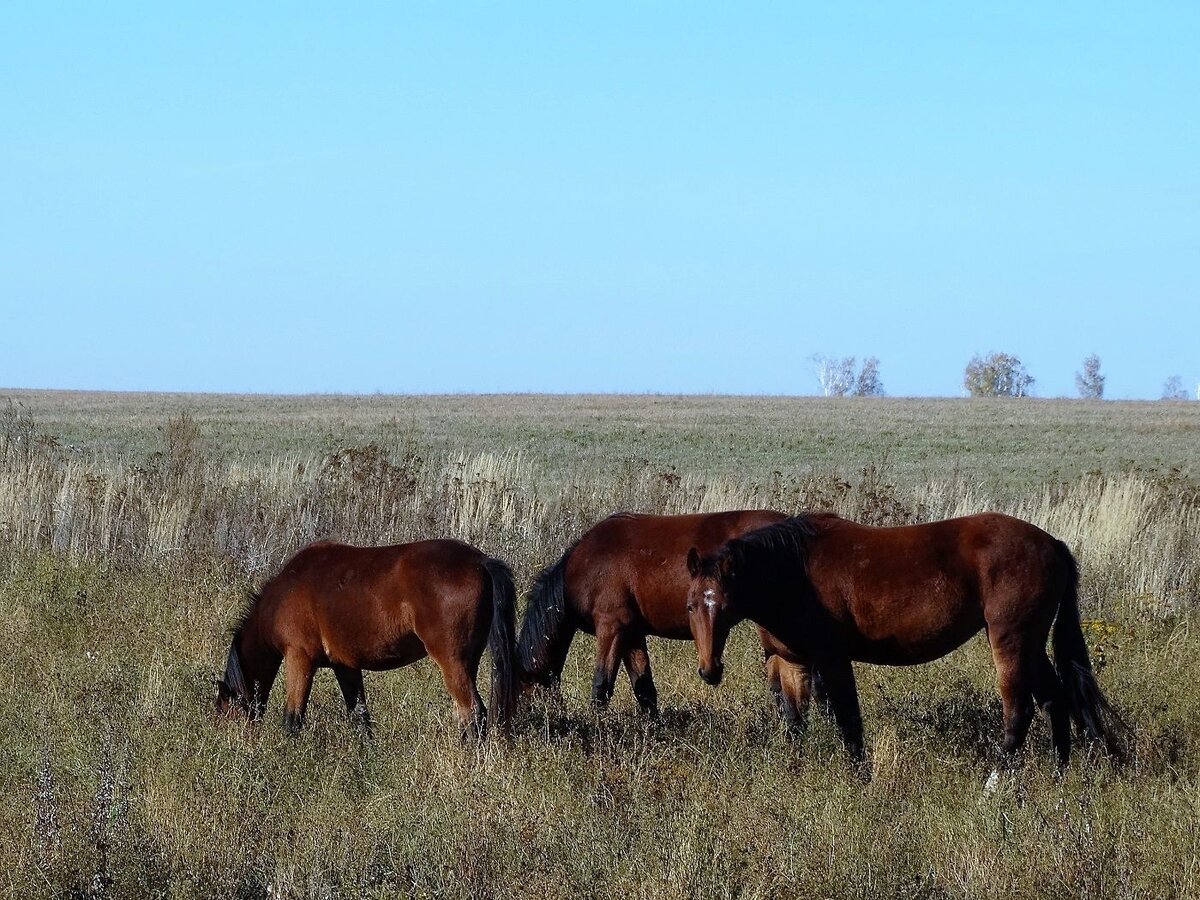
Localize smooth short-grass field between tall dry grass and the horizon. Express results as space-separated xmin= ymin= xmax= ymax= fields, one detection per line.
xmin=9 ymin=391 xmax=1200 ymax=493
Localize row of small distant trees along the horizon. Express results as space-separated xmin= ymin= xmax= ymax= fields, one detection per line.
xmin=810 ymin=350 xmax=1200 ymax=400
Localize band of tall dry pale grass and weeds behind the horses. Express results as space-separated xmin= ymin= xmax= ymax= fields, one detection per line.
xmin=0 ymin=407 xmax=1200 ymax=611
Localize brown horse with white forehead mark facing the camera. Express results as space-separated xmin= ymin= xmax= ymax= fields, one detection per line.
xmin=688 ymin=514 xmax=1126 ymax=766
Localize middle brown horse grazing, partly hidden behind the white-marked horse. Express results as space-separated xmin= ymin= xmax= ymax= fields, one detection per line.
xmin=517 ymin=510 xmax=816 ymax=715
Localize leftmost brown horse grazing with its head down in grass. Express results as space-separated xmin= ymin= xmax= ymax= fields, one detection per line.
xmin=217 ymin=540 xmax=516 ymax=736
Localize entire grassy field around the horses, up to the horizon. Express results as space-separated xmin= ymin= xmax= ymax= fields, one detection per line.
xmin=0 ymin=391 xmax=1200 ymax=898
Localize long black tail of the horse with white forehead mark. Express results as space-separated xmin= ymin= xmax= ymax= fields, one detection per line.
xmin=1052 ymin=541 xmax=1130 ymax=761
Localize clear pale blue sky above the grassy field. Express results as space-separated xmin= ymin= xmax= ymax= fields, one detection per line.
xmin=0 ymin=2 xmax=1200 ymax=397
